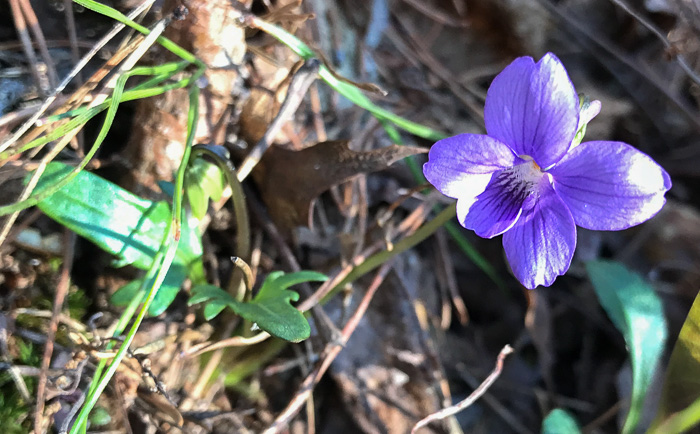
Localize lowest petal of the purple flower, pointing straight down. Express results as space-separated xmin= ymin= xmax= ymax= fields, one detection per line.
xmin=503 ymin=182 xmax=576 ymax=289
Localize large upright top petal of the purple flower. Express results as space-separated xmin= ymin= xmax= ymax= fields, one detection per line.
xmin=484 ymin=53 xmax=579 ymax=169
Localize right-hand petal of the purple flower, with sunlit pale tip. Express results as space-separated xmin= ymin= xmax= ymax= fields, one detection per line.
xmin=549 ymin=141 xmax=671 ymax=231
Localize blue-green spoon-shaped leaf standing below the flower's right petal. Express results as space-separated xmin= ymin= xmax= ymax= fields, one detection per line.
xmin=586 ymin=261 xmax=667 ymax=433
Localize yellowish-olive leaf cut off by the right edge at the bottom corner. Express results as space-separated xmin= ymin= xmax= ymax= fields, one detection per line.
xmin=651 ymin=288 xmax=700 ymax=433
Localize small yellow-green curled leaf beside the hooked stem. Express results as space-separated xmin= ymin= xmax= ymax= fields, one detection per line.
xmin=185 ymin=158 xmax=226 ymax=220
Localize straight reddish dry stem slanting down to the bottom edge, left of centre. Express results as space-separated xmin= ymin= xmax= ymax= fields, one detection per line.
xmin=264 ymin=260 xmax=393 ymax=434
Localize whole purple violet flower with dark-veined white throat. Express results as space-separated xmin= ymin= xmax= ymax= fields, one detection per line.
xmin=423 ymin=53 xmax=671 ymax=289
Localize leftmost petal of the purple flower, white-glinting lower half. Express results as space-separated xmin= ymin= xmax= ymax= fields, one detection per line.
xmin=423 ymin=134 xmax=517 ymax=199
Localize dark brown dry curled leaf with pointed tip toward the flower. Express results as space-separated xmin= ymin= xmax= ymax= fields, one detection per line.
xmin=253 ymin=140 xmax=428 ymax=235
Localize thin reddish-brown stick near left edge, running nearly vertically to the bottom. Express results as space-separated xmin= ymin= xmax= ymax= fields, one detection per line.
xmin=34 ymin=229 xmax=76 ymax=434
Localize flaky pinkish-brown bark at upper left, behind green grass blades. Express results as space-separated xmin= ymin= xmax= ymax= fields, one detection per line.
xmin=124 ymin=0 xmax=245 ymax=194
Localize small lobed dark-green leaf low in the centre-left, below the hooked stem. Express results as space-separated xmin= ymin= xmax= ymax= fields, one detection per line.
xmin=189 ymin=271 xmax=328 ymax=342
